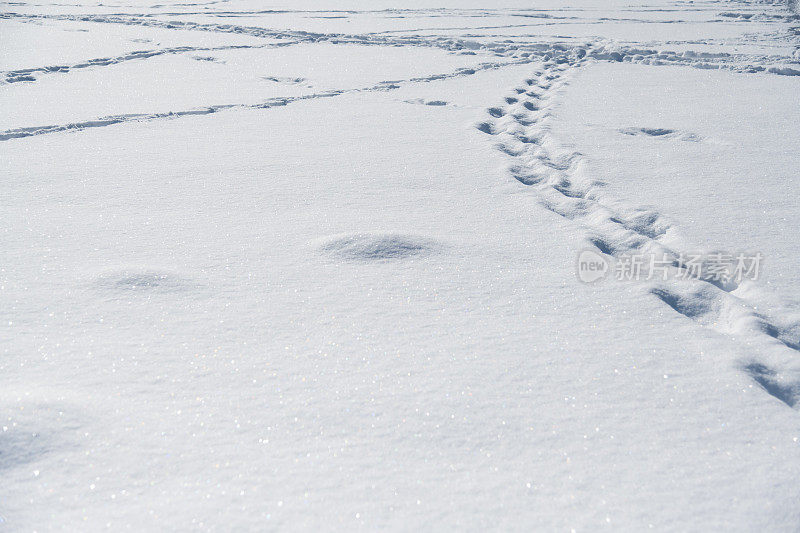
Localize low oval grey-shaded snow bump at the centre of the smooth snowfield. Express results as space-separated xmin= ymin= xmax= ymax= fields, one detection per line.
xmin=319 ymin=233 xmax=441 ymax=261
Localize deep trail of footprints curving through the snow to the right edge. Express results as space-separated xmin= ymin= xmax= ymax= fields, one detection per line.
xmin=476 ymin=59 xmax=800 ymax=407
